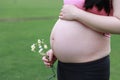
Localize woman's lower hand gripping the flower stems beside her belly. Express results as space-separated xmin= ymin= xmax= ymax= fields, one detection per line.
xmin=42 ymin=49 xmax=57 ymax=67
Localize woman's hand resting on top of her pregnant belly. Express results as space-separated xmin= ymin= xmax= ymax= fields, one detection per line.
xmin=59 ymin=5 xmax=80 ymax=20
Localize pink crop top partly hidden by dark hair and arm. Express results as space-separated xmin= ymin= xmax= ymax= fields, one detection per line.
xmin=64 ymin=0 xmax=113 ymax=37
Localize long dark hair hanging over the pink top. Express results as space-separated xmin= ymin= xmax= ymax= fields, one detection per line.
xmin=84 ymin=0 xmax=112 ymax=15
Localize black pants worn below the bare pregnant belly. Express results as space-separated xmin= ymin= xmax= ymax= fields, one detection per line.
xmin=57 ymin=56 xmax=110 ymax=80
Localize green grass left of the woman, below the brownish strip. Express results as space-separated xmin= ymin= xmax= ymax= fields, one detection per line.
xmin=0 ymin=20 xmax=57 ymax=80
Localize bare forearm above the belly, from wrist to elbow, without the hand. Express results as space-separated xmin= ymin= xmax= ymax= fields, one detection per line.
xmin=75 ymin=10 xmax=120 ymax=34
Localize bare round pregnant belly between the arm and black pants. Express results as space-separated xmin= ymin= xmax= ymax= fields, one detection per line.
xmin=51 ymin=20 xmax=108 ymax=62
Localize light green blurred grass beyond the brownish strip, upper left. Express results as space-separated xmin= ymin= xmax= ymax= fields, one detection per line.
xmin=0 ymin=0 xmax=62 ymax=18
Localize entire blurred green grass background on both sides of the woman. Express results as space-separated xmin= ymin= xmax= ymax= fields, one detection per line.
xmin=0 ymin=0 xmax=120 ymax=80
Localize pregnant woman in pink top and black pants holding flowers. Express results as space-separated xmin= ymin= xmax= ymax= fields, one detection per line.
xmin=43 ymin=0 xmax=120 ymax=80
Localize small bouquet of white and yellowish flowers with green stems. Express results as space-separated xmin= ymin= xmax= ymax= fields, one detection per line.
xmin=31 ymin=39 xmax=56 ymax=80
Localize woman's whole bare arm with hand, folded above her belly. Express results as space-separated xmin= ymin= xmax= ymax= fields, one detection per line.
xmin=60 ymin=0 xmax=120 ymax=34
